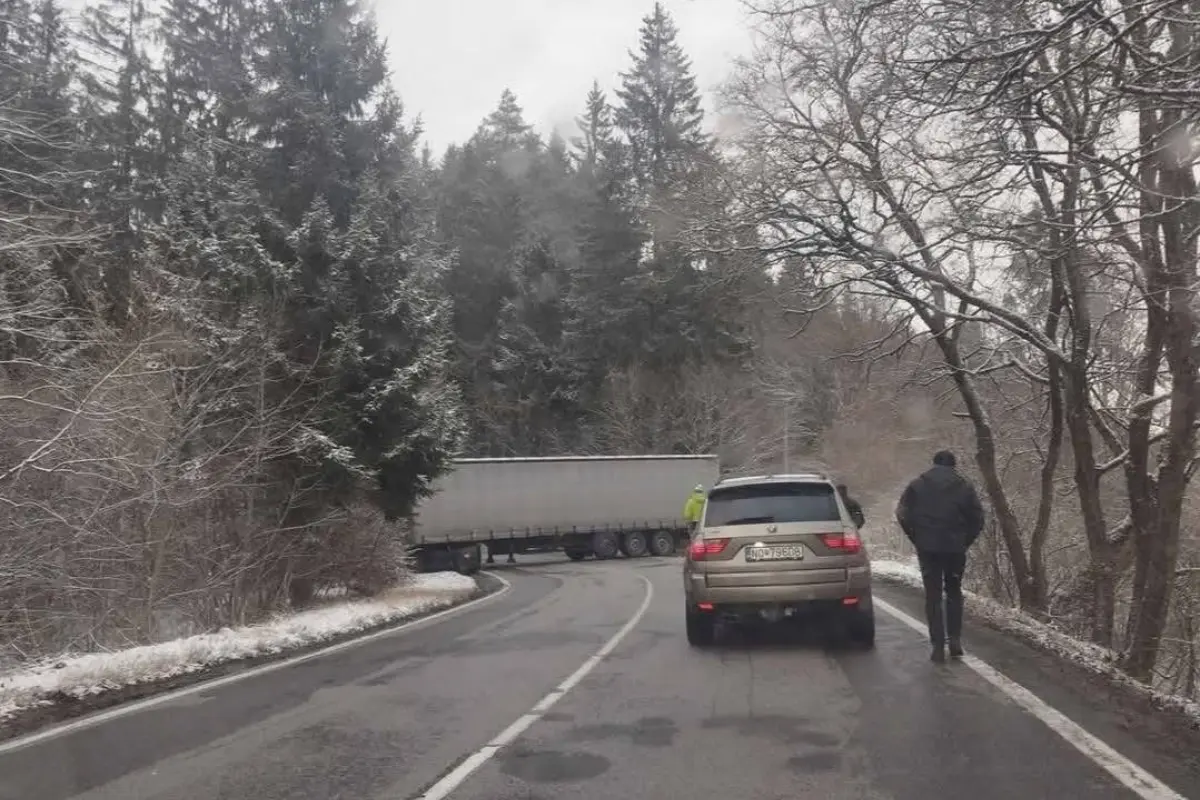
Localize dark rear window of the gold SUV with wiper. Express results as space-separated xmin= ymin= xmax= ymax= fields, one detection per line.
xmin=704 ymin=483 xmax=841 ymax=528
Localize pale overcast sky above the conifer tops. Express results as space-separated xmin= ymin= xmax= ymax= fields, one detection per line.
xmin=374 ymin=0 xmax=750 ymax=154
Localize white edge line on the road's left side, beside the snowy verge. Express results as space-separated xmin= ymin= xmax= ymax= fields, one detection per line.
xmin=0 ymin=572 xmax=512 ymax=754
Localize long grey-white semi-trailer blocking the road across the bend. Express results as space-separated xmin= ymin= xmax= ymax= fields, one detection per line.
xmin=410 ymin=456 xmax=720 ymax=572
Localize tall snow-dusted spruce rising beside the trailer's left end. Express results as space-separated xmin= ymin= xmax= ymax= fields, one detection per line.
xmin=258 ymin=0 xmax=458 ymax=517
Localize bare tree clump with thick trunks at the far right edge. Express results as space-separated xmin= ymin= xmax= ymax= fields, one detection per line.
xmin=907 ymin=2 xmax=1200 ymax=679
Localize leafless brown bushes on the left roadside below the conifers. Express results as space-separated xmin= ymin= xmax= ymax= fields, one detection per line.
xmin=0 ymin=299 xmax=417 ymax=661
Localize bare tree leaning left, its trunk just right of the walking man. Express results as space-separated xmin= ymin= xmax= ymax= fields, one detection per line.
xmin=728 ymin=0 xmax=1044 ymax=608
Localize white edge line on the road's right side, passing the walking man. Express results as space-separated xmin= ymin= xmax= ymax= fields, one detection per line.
xmin=874 ymin=597 xmax=1187 ymax=800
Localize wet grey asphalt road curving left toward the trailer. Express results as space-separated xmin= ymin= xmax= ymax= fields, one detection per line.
xmin=0 ymin=559 xmax=1200 ymax=800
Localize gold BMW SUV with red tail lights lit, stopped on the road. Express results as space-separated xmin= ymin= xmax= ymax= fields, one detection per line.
xmin=683 ymin=473 xmax=875 ymax=648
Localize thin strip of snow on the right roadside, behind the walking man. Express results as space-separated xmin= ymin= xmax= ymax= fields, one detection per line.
xmin=871 ymin=559 xmax=1200 ymax=724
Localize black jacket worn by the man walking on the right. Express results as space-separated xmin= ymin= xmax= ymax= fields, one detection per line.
xmin=896 ymin=467 xmax=983 ymax=553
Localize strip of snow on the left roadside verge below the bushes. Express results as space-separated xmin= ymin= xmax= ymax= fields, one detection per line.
xmin=0 ymin=572 xmax=476 ymax=721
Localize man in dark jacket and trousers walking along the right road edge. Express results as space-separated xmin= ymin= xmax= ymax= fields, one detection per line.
xmin=896 ymin=450 xmax=983 ymax=663
